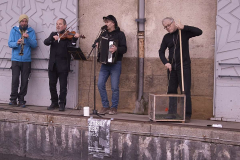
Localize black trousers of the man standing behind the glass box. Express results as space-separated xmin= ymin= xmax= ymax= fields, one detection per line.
xmin=168 ymin=66 xmax=192 ymax=117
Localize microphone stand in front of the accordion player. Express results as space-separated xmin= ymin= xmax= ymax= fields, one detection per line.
xmin=87 ymin=30 xmax=106 ymax=117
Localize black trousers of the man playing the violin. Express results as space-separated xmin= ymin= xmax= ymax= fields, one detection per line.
xmin=48 ymin=65 xmax=68 ymax=105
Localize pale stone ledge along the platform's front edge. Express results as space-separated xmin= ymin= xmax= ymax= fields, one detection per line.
xmin=0 ymin=111 xmax=240 ymax=146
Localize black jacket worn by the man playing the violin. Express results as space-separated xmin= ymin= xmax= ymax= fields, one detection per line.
xmin=44 ymin=32 xmax=77 ymax=72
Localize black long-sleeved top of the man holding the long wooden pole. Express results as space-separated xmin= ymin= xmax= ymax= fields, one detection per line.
xmin=159 ymin=25 xmax=202 ymax=69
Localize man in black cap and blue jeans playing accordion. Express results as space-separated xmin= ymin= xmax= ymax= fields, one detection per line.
xmin=98 ymin=15 xmax=127 ymax=114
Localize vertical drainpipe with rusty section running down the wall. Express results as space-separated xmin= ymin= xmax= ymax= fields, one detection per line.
xmin=134 ymin=0 xmax=146 ymax=114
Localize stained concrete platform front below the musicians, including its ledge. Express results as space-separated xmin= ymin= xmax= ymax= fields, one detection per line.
xmin=0 ymin=111 xmax=240 ymax=160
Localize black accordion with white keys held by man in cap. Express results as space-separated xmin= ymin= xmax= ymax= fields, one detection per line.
xmin=97 ymin=37 xmax=118 ymax=64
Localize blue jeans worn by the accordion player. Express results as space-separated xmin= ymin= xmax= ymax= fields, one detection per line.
xmin=98 ymin=61 xmax=122 ymax=108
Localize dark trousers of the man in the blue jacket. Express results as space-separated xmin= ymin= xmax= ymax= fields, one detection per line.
xmin=10 ymin=61 xmax=31 ymax=103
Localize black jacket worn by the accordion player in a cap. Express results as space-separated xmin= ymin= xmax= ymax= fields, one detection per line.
xmin=98 ymin=27 xmax=127 ymax=61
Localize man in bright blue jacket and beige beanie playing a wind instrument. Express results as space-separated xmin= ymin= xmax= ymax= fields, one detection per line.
xmin=8 ymin=14 xmax=37 ymax=108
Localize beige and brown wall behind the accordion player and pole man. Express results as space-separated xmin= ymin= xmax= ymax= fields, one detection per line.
xmin=79 ymin=0 xmax=217 ymax=119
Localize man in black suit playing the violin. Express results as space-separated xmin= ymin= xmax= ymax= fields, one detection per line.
xmin=44 ymin=18 xmax=80 ymax=111
